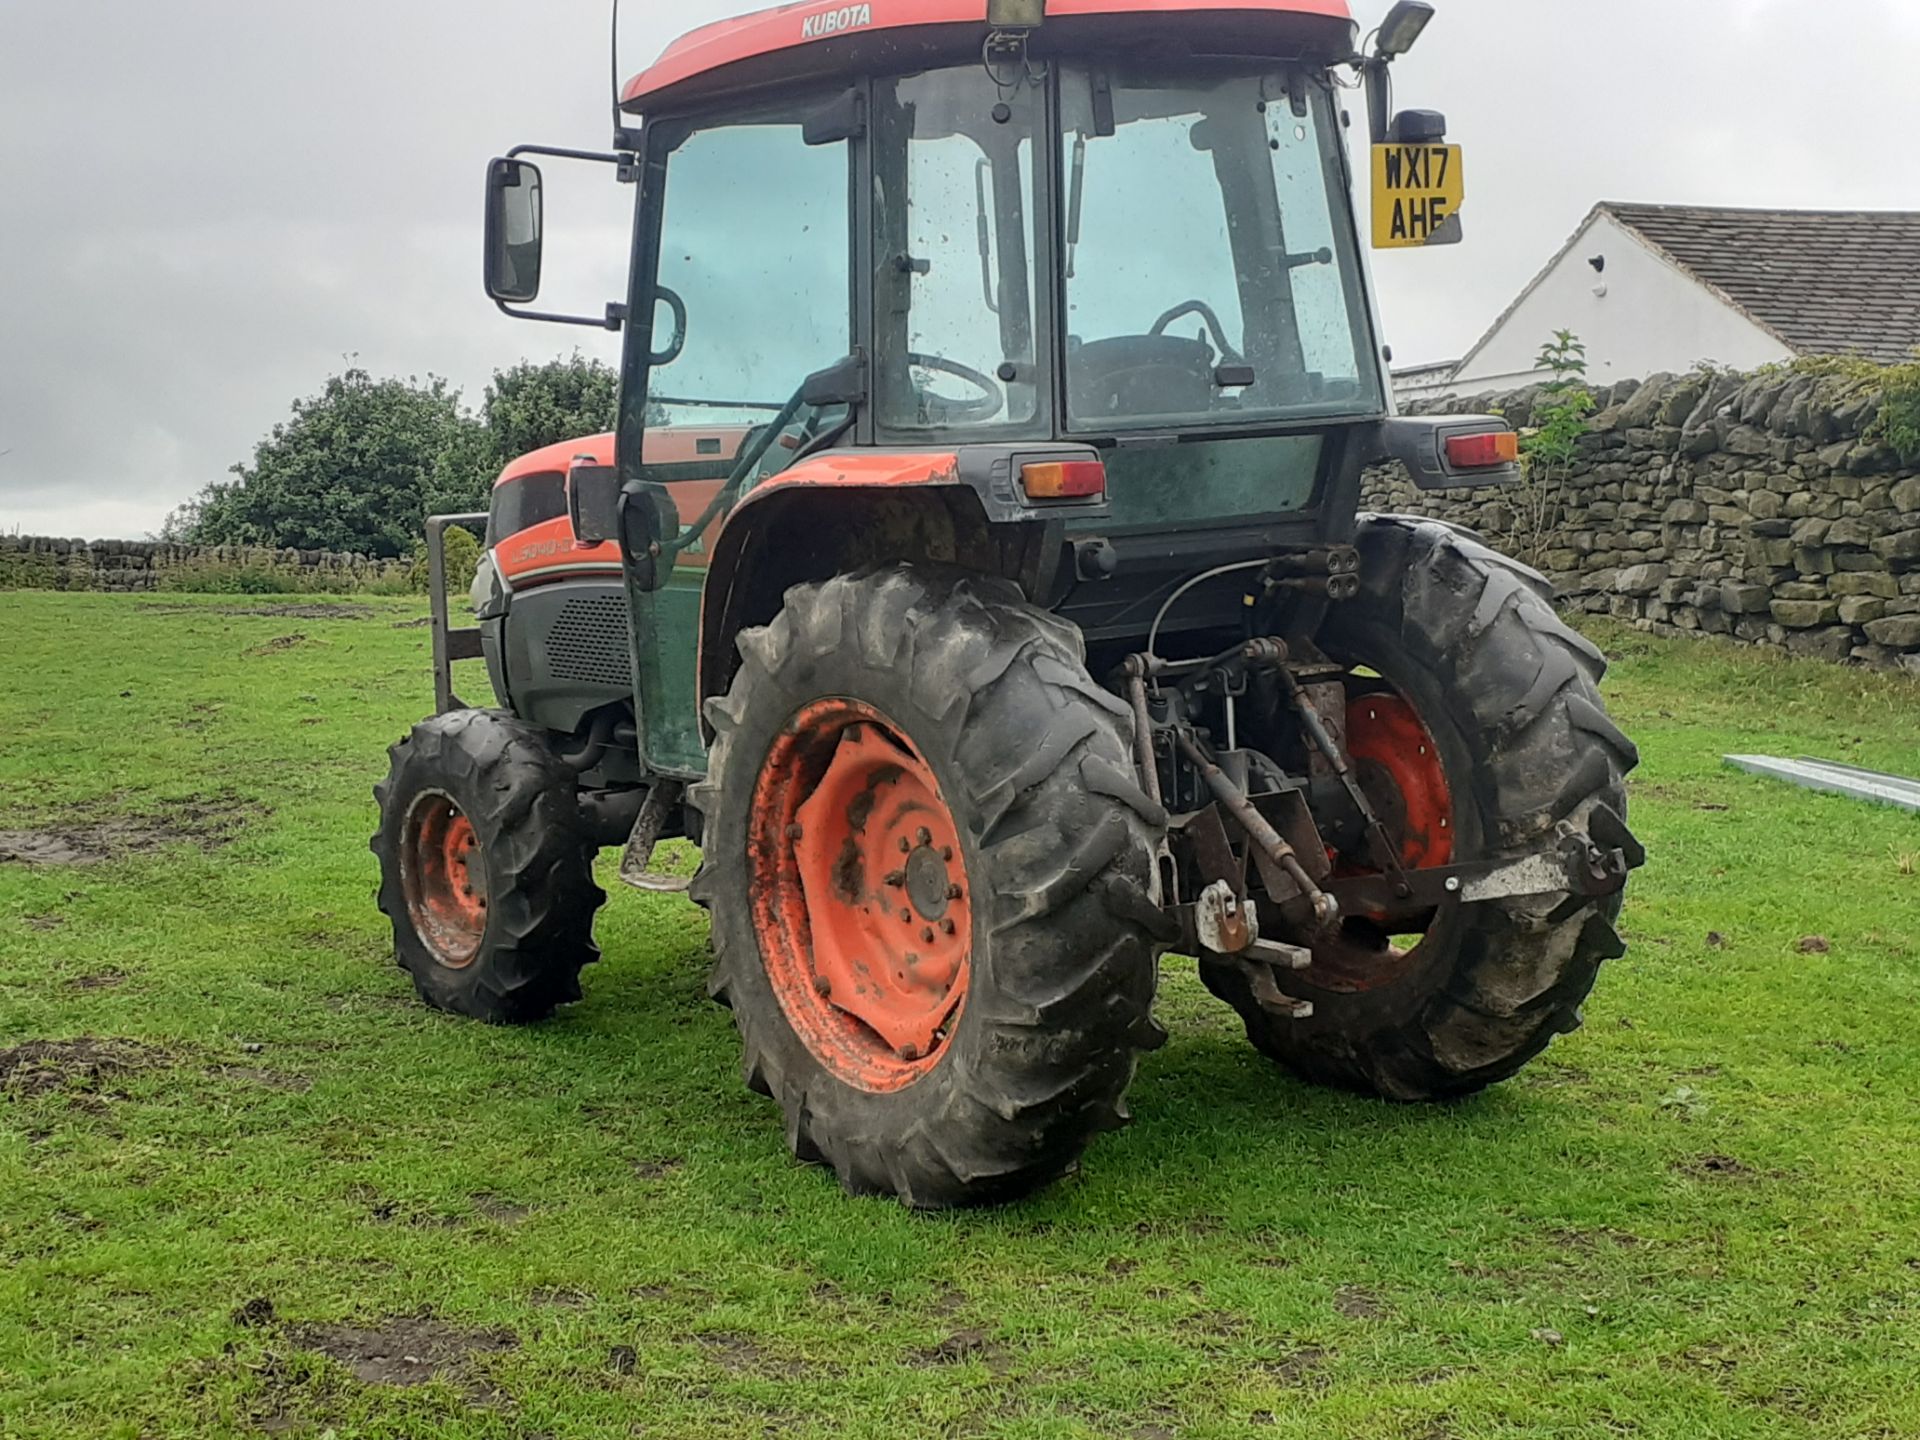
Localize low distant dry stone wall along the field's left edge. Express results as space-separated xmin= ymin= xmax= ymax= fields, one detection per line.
xmin=0 ymin=536 xmax=407 ymax=593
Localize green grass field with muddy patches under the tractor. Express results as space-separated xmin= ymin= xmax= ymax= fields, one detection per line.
xmin=0 ymin=593 xmax=1920 ymax=1440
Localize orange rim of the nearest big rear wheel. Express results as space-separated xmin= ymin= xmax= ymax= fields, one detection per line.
xmin=747 ymin=699 xmax=973 ymax=1092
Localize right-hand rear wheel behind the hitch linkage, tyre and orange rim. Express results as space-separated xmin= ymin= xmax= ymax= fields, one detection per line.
xmin=1200 ymin=516 xmax=1642 ymax=1100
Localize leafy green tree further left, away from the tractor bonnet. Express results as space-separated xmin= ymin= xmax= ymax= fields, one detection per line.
xmin=165 ymin=369 xmax=484 ymax=557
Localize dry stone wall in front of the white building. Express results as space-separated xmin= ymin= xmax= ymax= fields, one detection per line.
xmin=1363 ymin=372 xmax=1920 ymax=674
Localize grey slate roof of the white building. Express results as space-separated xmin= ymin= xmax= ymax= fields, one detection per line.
xmin=1599 ymin=202 xmax=1920 ymax=363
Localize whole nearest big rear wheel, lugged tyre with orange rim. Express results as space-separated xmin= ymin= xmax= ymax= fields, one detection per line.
xmin=691 ymin=566 xmax=1165 ymax=1210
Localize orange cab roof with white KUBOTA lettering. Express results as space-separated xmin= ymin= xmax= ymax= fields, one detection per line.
xmin=620 ymin=0 xmax=1357 ymax=111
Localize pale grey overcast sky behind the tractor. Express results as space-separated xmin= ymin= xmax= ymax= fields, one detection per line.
xmin=0 ymin=0 xmax=1920 ymax=538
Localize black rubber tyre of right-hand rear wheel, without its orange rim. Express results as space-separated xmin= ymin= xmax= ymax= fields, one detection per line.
xmin=1202 ymin=515 xmax=1644 ymax=1100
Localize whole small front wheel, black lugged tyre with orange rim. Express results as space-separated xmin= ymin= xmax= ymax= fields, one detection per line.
xmin=372 ymin=710 xmax=607 ymax=1025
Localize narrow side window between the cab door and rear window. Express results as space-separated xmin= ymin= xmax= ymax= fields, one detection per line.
xmin=874 ymin=67 xmax=1043 ymax=430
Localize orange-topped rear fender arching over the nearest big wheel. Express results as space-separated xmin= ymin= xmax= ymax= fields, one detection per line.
xmin=699 ymin=445 xmax=1106 ymax=726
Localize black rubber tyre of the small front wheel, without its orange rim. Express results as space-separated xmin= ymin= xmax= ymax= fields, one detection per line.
xmin=371 ymin=710 xmax=607 ymax=1025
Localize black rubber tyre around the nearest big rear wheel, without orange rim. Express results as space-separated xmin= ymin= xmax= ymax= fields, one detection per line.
xmin=691 ymin=566 xmax=1165 ymax=1210
